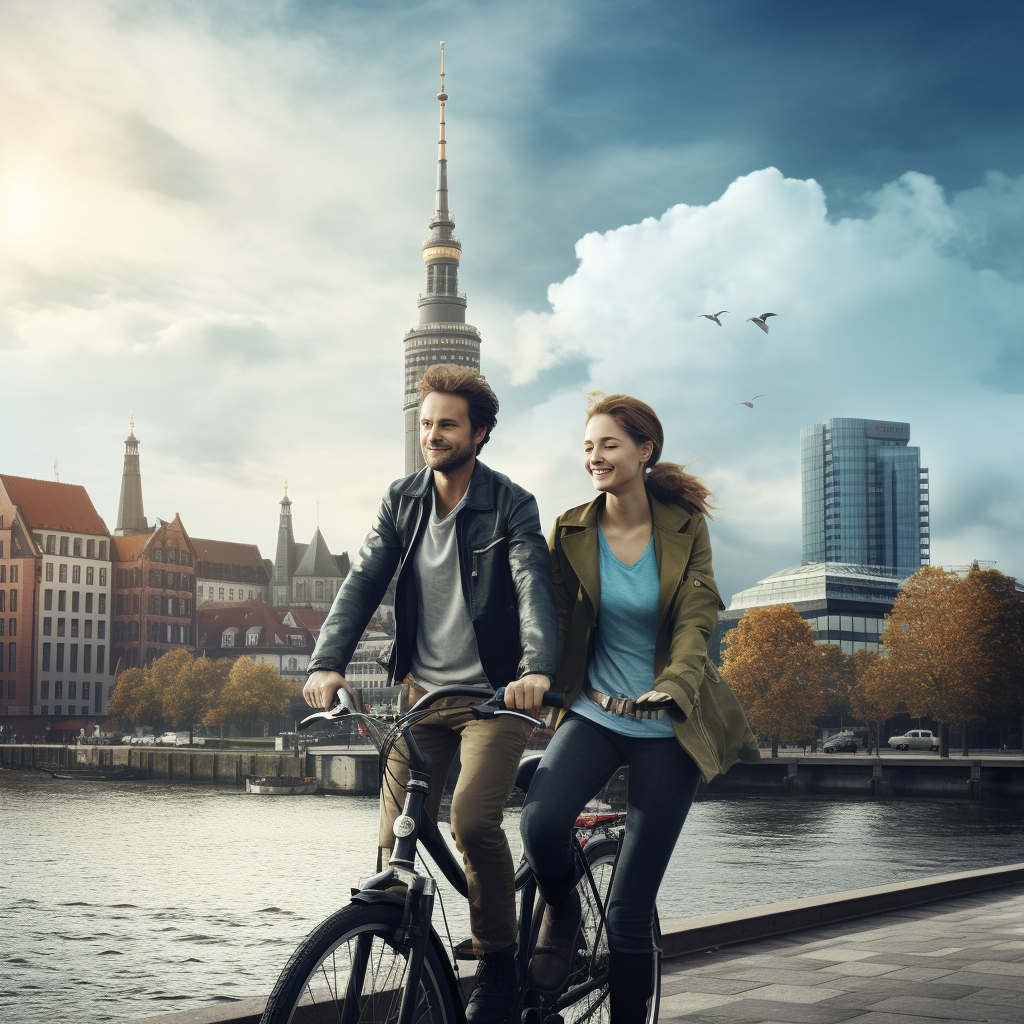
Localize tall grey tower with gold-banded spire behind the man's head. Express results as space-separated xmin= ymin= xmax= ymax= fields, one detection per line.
xmin=402 ymin=43 xmax=480 ymax=474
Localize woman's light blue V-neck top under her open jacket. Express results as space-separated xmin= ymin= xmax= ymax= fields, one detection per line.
xmin=572 ymin=524 xmax=675 ymax=738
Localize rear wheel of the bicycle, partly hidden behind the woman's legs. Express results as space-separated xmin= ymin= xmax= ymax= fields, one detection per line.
xmin=560 ymin=838 xmax=662 ymax=1024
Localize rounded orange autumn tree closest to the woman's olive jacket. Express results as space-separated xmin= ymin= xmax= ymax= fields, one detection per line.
xmin=722 ymin=604 xmax=824 ymax=758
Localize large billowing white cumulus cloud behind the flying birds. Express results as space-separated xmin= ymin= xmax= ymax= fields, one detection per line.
xmin=483 ymin=168 xmax=1024 ymax=593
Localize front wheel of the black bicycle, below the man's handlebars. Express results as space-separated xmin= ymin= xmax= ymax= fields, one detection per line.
xmin=260 ymin=903 xmax=457 ymax=1024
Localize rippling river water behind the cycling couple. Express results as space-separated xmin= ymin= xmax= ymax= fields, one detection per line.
xmin=6 ymin=772 xmax=1024 ymax=1024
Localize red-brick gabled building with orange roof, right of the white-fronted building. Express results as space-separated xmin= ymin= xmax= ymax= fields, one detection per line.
xmin=111 ymin=513 xmax=196 ymax=672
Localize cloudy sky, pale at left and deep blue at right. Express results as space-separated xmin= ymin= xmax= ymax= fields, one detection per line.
xmin=0 ymin=0 xmax=1024 ymax=601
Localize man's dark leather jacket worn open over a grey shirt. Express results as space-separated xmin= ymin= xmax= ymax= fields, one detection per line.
xmin=306 ymin=460 xmax=558 ymax=688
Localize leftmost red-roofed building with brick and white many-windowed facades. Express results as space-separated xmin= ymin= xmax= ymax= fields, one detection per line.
xmin=0 ymin=475 xmax=113 ymax=735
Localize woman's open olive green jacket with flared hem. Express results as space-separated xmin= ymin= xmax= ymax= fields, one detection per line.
xmin=548 ymin=495 xmax=760 ymax=782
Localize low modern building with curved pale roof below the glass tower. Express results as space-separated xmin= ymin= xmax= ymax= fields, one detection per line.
xmin=708 ymin=562 xmax=910 ymax=665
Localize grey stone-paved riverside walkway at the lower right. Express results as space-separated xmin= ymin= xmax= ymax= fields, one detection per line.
xmin=659 ymin=886 xmax=1024 ymax=1024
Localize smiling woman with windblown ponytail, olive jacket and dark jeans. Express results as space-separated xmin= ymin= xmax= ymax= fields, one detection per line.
xmin=521 ymin=392 xmax=759 ymax=1024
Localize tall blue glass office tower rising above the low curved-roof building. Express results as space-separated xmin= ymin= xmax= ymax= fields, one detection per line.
xmin=800 ymin=419 xmax=930 ymax=574
